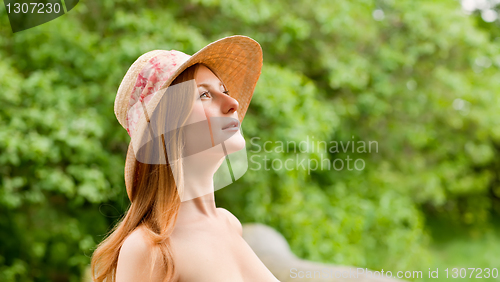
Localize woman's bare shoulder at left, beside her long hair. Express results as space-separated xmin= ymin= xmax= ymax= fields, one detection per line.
xmin=116 ymin=228 xmax=166 ymax=282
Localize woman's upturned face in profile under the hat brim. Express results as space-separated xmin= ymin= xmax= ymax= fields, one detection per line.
xmin=184 ymin=65 xmax=245 ymax=157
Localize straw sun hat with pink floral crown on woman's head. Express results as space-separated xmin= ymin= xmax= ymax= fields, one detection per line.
xmin=114 ymin=35 xmax=262 ymax=200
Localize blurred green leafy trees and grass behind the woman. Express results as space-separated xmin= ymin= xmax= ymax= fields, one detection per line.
xmin=0 ymin=0 xmax=500 ymax=282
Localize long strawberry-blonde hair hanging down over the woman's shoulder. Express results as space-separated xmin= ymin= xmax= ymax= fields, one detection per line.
xmin=91 ymin=64 xmax=199 ymax=282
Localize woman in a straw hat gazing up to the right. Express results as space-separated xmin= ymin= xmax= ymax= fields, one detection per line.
xmin=92 ymin=36 xmax=278 ymax=282
